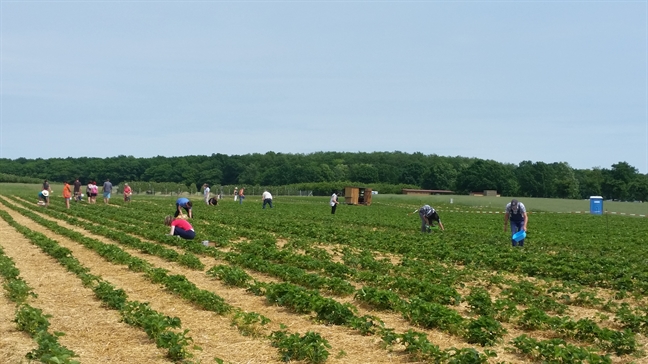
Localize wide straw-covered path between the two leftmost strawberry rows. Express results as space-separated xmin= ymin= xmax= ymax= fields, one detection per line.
xmin=0 ymin=220 xmax=169 ymax=363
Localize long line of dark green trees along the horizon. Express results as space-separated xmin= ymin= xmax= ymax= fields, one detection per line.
xmin=0 ymin=152 xmax=648 ymax=201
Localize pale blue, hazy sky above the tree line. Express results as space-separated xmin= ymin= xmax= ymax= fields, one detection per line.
xmin=0 ymin=0 xmax=648 ymax=173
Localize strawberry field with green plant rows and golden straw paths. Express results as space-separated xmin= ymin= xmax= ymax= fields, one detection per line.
xmin=0 ymin=193 xmax=648 ymax=363
